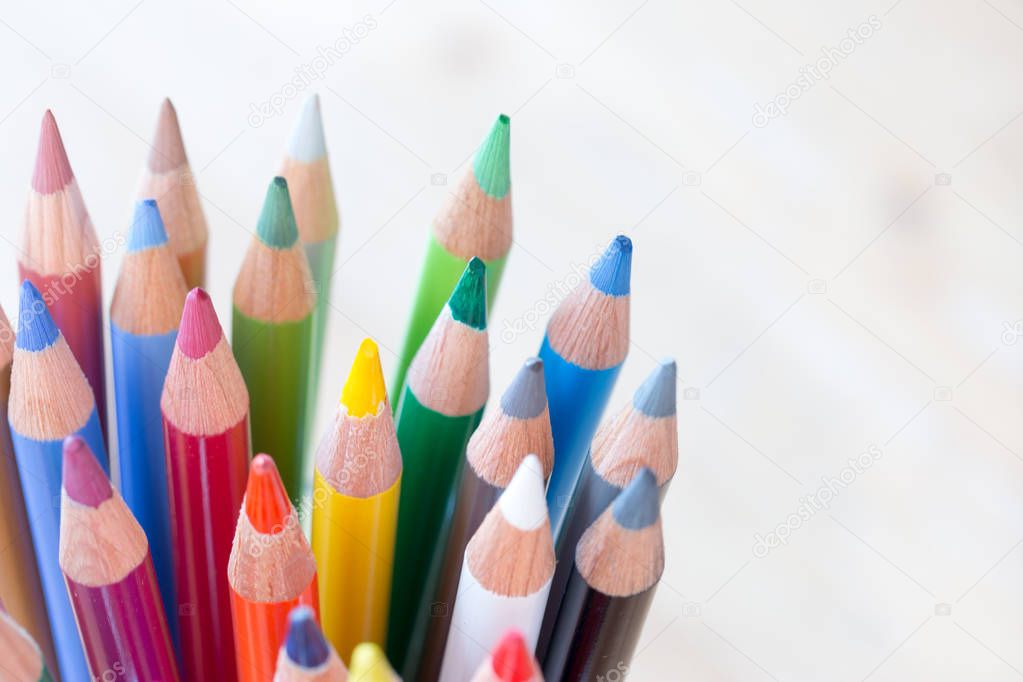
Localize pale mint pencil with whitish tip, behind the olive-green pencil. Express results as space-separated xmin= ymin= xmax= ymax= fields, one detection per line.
xmin=280 ymin=94 xmax=340 ymax=404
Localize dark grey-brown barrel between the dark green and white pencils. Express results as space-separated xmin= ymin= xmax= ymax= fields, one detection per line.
xmin=405 ymin=466 xmax=501 ymax=680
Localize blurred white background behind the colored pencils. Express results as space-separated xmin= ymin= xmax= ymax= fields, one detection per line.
xmin=0 ymin=0 xmax=1023 ymax=681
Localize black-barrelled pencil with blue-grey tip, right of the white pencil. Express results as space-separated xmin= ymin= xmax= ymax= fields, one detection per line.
xmin=543 ymin=469 xmax=664 ymax=682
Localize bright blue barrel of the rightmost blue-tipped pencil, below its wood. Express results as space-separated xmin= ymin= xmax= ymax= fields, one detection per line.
xmin=540 ymin=336 xmax=622 ymax=538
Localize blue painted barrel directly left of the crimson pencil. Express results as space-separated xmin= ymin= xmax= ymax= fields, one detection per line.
xmin=110 ymin=322 xmax=178 ymax=645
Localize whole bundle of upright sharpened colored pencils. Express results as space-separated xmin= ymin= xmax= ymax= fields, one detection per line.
xmin=0 ymin=101 xmax=678 ymax=682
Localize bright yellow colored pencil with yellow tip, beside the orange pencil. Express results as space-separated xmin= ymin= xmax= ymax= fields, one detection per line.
xmin=312 ymin=338 xmax=401 ymax=657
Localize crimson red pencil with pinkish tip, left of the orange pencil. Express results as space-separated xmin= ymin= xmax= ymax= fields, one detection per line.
xmin=160 ymin=289 xmax=252 ymax=680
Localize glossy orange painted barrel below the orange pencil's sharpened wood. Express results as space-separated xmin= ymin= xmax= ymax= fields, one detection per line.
xmin=230 ymin=576 xmax=316 ymax=682
